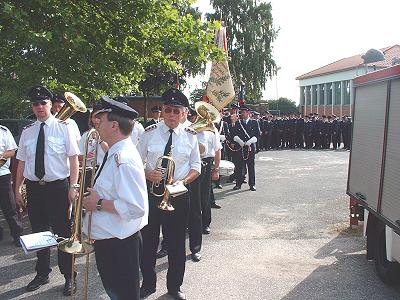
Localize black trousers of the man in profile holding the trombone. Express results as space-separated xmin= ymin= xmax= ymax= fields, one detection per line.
xmin=94 ymin=232 xmax=141 ymax=300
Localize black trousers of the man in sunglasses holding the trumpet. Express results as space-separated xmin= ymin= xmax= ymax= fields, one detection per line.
xmin=140 ymin=193 xmax=189 ymax=292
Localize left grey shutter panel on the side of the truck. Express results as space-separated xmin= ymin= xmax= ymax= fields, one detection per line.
xmin=348 ymin=82 xmax=387 ymax=211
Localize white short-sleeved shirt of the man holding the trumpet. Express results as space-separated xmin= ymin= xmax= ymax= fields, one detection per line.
xmin=138 ymin=121 xmax=201 ymax=180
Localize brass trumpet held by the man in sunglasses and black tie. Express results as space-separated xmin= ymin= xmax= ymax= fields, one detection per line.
xmin=150 ymin=146 xmax=175 ymax=211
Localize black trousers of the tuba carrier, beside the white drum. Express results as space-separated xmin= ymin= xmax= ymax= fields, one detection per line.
xmin=200 ymin=157 xmax=214 ymax=228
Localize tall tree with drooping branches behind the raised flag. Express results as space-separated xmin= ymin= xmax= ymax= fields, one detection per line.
xmin=208 ymin=0 xmax=277 ymax=103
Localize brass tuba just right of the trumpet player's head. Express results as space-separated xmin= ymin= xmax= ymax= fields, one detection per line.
xmin=189 ymin=101 xmax=221 ymax=132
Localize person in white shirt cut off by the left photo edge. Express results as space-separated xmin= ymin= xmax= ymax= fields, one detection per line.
xmin=0 ymin=125 xmax=23 ymax=247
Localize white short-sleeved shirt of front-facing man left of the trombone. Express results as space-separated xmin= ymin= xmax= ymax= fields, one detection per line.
xmin=17 ymin=116 xmax=79 ymax=182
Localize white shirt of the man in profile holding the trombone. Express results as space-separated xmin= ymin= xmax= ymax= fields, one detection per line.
xmin=83 ymin=138 xmax=149 ymax=240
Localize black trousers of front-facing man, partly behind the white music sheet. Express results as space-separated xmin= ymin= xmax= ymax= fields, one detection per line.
xmin=26 ymin=179 xmax=72 ymax=277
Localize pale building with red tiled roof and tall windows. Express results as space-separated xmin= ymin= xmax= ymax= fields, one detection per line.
xmin=296 ymin=45 xmax=400 ymax=116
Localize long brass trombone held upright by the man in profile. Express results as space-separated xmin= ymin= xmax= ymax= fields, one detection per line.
xmin=58 ymin=128 xmax=100 ymax=299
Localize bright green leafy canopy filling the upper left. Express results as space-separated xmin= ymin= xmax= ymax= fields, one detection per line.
xmin=0 ymin=0 xmax=221 ymax=118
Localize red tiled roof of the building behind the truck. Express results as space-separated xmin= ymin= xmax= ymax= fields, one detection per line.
xmin=296 ymin=45 xmax=400 ymax=80
